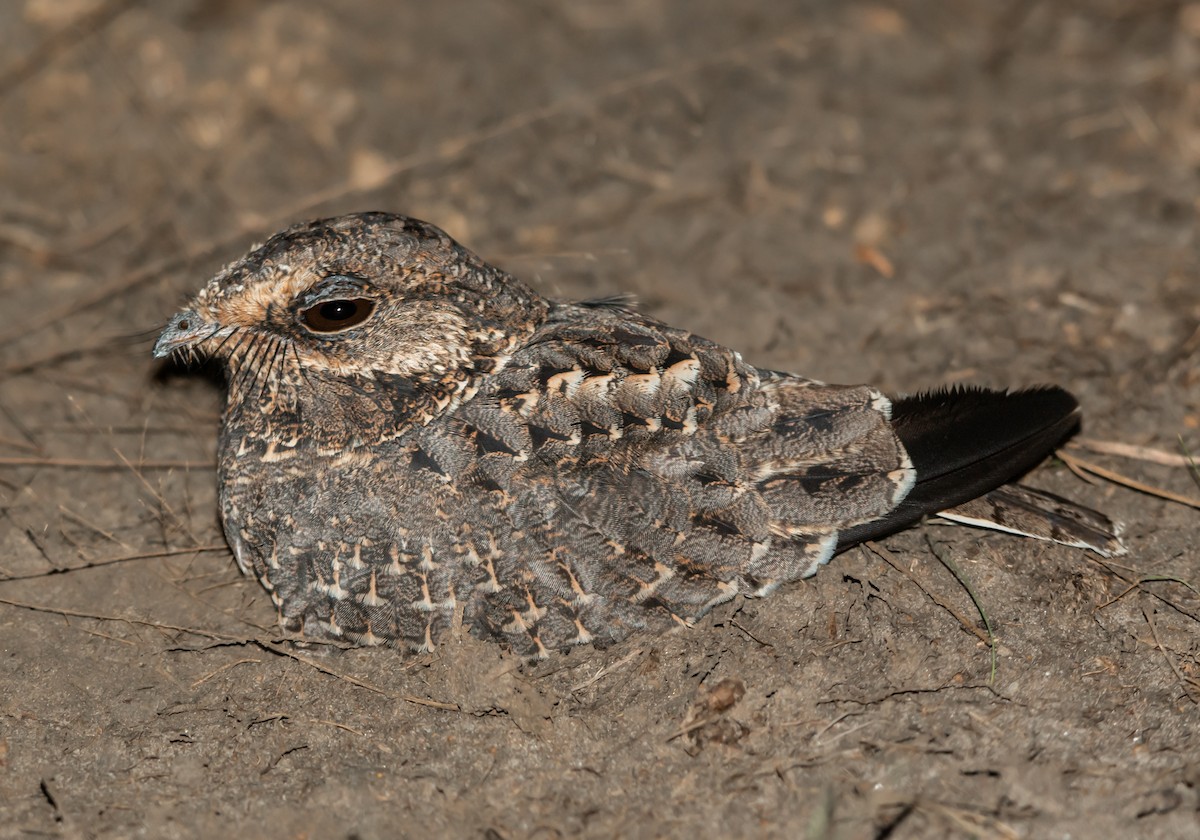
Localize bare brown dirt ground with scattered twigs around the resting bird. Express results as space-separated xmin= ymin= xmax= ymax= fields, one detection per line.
xmin=0 ymin=0 xmax=1200 ymax=840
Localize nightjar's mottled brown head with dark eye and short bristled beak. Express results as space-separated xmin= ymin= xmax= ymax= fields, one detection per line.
xmin=154 ymin=212 xmax=547 ymax=446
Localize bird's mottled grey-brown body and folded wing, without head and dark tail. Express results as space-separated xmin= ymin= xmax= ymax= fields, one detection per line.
xmin=222 ymin=280 xmax=912 ymax=655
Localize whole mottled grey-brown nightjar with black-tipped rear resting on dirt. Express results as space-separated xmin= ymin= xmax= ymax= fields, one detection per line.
xmin=155 ymin=212 xmax=1122 ymax=656
